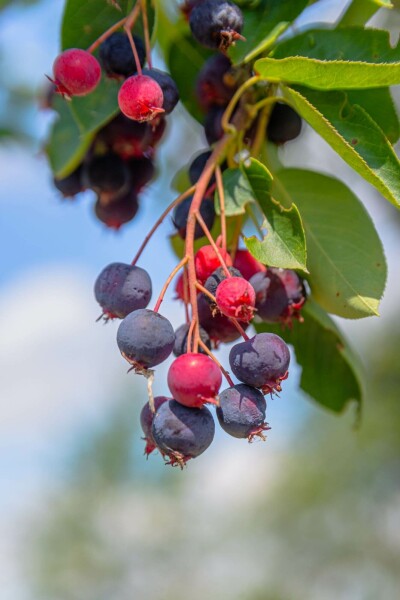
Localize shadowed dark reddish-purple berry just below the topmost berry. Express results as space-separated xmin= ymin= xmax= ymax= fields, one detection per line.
xmin=196 ymin=54 xmax=236 ymax=111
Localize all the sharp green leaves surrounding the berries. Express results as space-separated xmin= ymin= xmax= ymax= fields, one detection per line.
xmin=48 ymin=0 xmax=400 ymax=412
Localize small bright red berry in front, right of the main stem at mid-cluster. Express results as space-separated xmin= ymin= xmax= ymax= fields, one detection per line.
xmin=215 ymin=277 xmax=256 ymax=321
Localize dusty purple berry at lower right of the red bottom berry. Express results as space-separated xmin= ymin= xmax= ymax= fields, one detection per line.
xmin=217 ymin=383 xmax=269 ymax=442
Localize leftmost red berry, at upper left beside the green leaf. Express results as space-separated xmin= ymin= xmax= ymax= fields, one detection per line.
xmin=53 ymin=48 xmax=101 ymax=96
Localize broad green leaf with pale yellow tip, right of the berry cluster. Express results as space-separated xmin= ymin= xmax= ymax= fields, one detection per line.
xmin=272 ymin=169 xmax=387 ymax=319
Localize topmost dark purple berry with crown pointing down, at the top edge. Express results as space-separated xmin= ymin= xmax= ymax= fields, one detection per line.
xmin=189 ymin=0 xmax=243 ymax=50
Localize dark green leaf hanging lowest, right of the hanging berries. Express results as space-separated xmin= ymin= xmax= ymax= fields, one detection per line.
xmin=255 ymin=299 xmax=363 ymax=413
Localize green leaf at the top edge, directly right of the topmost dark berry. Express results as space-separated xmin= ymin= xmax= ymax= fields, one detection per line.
xmin=229 ymin=0 xmax=308 ymax=64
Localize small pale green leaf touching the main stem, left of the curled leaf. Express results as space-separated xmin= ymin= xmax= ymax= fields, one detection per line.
xmin=215 ymin=169 xmax=255 ymax=217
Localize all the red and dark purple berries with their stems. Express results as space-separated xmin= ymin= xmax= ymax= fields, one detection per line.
xmin=49 ymin=0 xmax=306 ymax=467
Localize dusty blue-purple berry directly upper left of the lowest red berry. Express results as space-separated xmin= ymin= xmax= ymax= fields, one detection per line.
xmin=117 ymin=309 xmax=175 ymax=371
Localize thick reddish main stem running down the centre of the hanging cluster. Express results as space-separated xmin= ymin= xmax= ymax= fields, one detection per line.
xmin=185 ymin=135 xmax=231 ymax=352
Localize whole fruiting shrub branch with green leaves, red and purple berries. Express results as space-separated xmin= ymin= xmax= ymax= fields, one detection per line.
xmin=43 ymin=0 xmax=400 ymax=467
